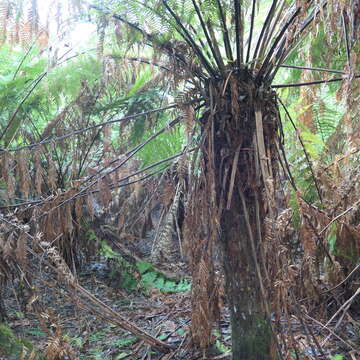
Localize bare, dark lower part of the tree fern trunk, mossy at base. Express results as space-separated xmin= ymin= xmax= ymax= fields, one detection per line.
xmin=221 ymin=202 xmax=271 ymax=360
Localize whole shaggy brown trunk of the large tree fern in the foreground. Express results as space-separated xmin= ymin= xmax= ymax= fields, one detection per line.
xmin=197 ymin=72 xmax=278 ymax=360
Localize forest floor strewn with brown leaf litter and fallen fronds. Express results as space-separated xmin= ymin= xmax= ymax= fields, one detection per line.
xmin=0 ymin=256 xmax=360 ymax=360
